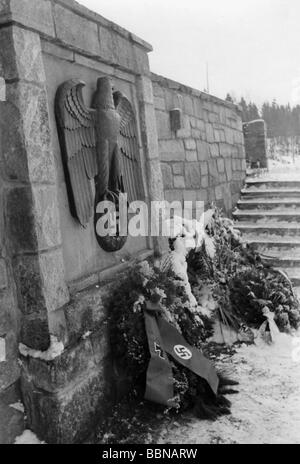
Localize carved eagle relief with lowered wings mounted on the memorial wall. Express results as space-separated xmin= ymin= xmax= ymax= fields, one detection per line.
xmin=55 ymin=77 xmax=141 ymax=251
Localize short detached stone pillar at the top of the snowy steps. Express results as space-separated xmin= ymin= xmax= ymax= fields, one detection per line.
xmin=243 ymin=119 xmax=268 ymax=168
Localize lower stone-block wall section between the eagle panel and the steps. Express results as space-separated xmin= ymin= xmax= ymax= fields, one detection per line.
xmin=152 ymin=74 xmax=246 ymax=214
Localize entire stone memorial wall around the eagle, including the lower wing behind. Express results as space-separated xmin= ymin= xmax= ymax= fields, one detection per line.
xmin=0 ymin=0 xmax=245 ymax=443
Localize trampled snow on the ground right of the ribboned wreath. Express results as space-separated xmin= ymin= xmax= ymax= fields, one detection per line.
xmin=158 ymin=332 xmax=300 ymax=444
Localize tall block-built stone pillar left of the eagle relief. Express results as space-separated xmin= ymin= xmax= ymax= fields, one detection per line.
xmin=0 ymin=21 xmax=69 ymax=350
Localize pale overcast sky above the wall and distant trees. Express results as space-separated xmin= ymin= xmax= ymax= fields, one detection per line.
xmin=79 ymin=0 xmax=300 ymax=104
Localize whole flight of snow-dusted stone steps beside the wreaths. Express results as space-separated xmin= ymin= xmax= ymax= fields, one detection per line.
xmin=233 ymin=179 xmax=300 ymax=290
